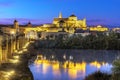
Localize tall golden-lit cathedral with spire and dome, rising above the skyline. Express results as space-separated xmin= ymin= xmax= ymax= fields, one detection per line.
xmin=53 ymin=13 xmax=87 ymax=30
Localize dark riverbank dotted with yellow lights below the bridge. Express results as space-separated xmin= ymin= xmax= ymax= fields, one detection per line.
xmin=0 ymin=44 xmax=34 ymax=80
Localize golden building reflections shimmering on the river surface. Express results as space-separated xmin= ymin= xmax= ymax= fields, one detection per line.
xmin=34 ymin=55 xmax=107 ymax=79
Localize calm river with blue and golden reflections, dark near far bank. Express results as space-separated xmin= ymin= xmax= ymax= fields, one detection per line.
xmin=29 ymin=49 xmax=120 ymax=80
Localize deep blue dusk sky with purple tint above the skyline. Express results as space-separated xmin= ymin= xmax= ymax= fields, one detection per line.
xmin=0 ymin=0 xmax=120 ymax=26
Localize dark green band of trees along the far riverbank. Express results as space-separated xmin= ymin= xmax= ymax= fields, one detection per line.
xmin=34 ymin=33 xmax=120 ymax=50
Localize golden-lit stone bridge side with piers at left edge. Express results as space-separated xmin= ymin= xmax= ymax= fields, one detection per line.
xmin=0 ymin=35 xmax=28 ymax=64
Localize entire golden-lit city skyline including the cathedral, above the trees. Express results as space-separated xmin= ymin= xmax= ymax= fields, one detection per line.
xmin=1 ymin=13 xmax=108 ymax=39
